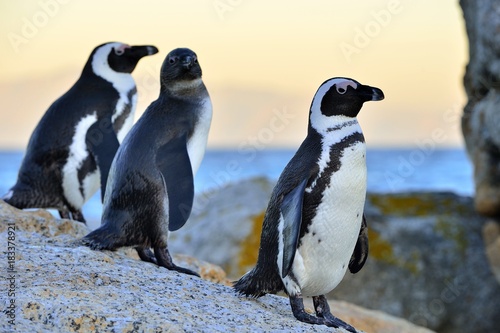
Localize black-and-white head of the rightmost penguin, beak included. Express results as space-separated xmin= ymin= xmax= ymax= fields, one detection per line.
xmin=311 ymin=77 xmax=384 ymax=118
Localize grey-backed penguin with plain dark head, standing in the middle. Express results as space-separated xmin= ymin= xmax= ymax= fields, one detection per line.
xmin=82 ymin=48 xmax=212 ymax=276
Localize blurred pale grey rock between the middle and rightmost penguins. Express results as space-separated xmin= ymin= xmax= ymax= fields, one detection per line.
xmin=169 ymin=178 xmax=274 ymax=279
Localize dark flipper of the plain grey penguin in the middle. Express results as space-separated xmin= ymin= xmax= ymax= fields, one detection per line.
xmin=156 ymin=135 xmax=194 ymax=231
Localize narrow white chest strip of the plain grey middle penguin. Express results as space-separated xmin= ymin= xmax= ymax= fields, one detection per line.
xmin=187 ymin=97 xmax=212 ymax=176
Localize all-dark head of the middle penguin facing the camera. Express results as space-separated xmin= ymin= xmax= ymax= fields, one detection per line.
xmin=160 ymin=48 xmax=202 ymax=91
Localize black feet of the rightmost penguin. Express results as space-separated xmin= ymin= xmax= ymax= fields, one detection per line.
xmin=290 ymin=294 xmax=358 ymax=333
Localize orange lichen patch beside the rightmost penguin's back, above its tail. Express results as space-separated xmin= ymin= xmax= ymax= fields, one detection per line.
xmin=237 ymin=211 xmax=265 ymax=275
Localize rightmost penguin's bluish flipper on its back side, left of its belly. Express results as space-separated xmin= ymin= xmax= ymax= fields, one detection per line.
xmin=280 ymin=178 xmax=307 ymax=278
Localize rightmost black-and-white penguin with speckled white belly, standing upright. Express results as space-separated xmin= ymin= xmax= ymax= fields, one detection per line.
xmin=233 ymin=77 xmax=384 ymax=332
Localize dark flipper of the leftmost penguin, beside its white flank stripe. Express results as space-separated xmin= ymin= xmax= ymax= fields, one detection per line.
xmin=85 ymin=118 xmax=120 ymax=201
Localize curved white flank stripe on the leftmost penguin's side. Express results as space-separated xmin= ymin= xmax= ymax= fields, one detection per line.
xmin=62 ymin=111 xmax=99 ymax=209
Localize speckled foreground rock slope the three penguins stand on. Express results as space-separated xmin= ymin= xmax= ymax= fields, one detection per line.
xmin=0 ymin=200 xmax=431 ymax=333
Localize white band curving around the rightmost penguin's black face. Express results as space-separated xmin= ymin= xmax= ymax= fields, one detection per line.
xmin=310 ymin=79 xmax=358 ymax=133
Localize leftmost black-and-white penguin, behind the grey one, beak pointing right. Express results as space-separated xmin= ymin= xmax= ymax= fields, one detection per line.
xmin=2 ymin=42 xmax=158 ymax=223
